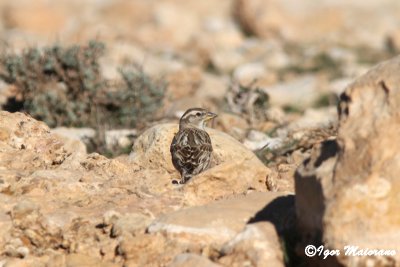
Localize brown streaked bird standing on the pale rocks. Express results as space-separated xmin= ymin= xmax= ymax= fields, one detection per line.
xmin=170 ymin=108 xmax=217 ymax=184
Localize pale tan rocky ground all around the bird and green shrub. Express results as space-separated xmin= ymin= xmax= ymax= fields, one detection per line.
xmin=0 ymin=0 xmax=400 ymax=267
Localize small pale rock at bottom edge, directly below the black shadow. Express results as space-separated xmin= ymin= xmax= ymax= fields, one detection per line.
xmin=219 ymin=222 xmax=284 ymax=267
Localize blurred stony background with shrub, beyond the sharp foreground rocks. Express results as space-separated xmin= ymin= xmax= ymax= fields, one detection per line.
xmin=0 ymin=0 xmax=400 ymax=156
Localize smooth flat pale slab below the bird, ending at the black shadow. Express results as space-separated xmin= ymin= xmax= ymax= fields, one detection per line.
xmin=148 ymin=192 xmax=291 ymax=245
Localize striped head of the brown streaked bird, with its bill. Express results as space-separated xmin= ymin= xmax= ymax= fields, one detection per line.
xmin=179 ymin=108 xmax=217 ymax=130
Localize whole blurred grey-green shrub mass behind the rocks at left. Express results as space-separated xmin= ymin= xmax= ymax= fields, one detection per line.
xmin=0 ymin=41 xmax=167 ymax=156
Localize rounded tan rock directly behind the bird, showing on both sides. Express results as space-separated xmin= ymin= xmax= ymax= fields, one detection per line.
xmin=130 ymin=124 xmax=270 ymax=205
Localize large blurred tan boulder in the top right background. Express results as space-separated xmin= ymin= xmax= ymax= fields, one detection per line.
xmin=234 ymin=0 xmax=400 ymax=47
